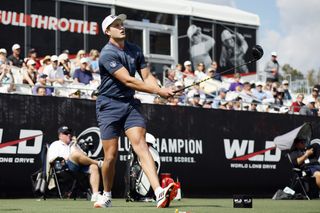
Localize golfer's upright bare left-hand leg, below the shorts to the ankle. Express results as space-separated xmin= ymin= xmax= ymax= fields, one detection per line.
xmin=101 ymin=137 xmax=118 ymax=192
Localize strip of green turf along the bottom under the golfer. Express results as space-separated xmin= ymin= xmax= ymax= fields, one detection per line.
xmin=0 ymin=199 xmax=320 ymax=213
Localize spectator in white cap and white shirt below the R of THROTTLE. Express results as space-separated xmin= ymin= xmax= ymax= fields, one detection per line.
xmin=43 ymin=55 xmax=64 ymax=86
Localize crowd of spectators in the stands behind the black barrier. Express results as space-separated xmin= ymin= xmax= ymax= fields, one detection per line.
xmin=0 ymin=44 xmax=320 ymax=116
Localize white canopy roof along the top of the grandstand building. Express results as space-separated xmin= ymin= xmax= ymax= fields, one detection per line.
xmin=79 ymin=0 xmax=260 ymax=26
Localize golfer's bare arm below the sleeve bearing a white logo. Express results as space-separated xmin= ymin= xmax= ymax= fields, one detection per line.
xmin=113 ymin=67 xmax=160 ymax=94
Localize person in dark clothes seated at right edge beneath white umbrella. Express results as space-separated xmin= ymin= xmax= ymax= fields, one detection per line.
xmin=290 ymin=138 xmax=320 ymax=189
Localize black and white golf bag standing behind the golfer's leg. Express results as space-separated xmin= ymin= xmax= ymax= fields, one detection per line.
xmin=125 ymin=133 xmax=160 ymax=202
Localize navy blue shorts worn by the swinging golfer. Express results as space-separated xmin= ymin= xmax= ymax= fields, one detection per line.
xmin=96 ymin=96 xmax=146 ymax=140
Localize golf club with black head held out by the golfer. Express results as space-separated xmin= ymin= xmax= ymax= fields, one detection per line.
xmin=174 ymin=45 xmax=263 ymax=93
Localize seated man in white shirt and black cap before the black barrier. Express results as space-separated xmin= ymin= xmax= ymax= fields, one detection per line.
xmin=48 ymin=126 xmax=103 ymax=201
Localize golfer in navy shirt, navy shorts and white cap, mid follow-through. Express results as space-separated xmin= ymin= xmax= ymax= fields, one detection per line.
xmin=94 ymin=14 xmax=175 ymax=208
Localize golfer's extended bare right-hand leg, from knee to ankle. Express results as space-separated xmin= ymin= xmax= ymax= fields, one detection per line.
xmin=125 ymin=127 xmax=160 ymax=191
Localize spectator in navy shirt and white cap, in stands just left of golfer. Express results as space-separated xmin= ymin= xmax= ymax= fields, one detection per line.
xmin=73 ymin=58 xmax=93 ymax=84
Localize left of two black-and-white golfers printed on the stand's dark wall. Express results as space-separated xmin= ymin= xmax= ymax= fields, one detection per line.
xmin=187 ymin=24 xmax=215 ymax=70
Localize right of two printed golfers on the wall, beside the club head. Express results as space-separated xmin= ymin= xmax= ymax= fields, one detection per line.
xmin=220 ymin=29 xmax=249 ymax=73
